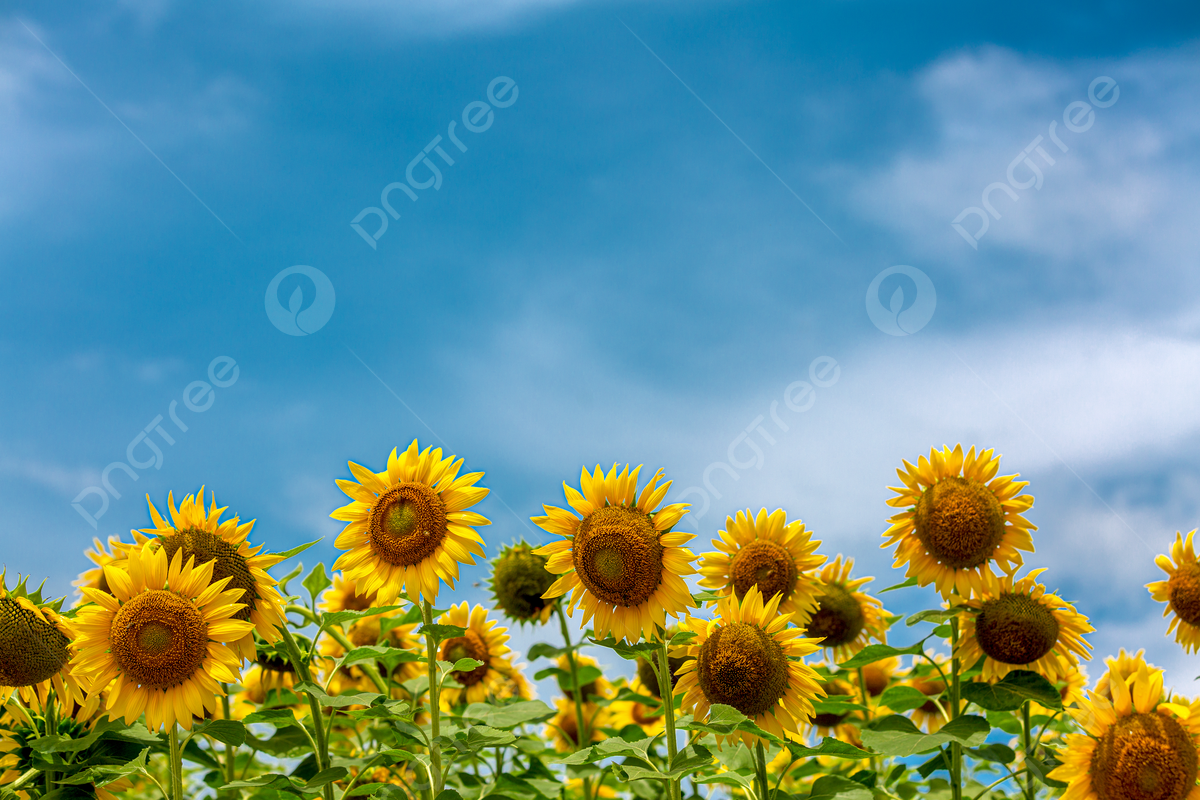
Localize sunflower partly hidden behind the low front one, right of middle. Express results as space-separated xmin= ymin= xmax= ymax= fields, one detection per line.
xmin=700 ymin=509 xmax=826 ymax=625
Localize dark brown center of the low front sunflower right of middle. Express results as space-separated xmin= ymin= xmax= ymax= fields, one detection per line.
xmin=696 ymin=622 xmax=787 ymax=717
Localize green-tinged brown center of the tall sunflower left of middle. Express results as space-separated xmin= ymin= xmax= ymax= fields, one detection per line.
xmin=367 ymin=481 xmax=446 ymax=566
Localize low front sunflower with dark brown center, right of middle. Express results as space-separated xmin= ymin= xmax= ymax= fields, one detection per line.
xmin=677 ymin=585 xmax=824 ymax=746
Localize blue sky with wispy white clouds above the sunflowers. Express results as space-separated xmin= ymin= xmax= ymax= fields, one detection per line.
xmin=0 ymin=0 xmax=1200 ymax=691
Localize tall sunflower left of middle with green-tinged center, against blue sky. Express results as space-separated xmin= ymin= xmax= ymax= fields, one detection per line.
xmin=329 ymin=439 xmax=492 ymax=604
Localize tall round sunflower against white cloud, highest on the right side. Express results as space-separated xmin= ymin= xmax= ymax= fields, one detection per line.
xmin=881 ymin=445 xmax=1037 ymax=597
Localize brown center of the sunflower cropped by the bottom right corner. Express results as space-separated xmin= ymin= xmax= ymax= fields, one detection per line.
xmin=1091 ymin=714 xmax=1196 ymax=800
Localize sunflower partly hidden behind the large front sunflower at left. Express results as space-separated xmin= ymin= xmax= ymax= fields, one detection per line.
xmin=132 ymin=486 xmax=284 ymax=661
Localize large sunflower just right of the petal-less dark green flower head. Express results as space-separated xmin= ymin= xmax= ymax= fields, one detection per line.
xmin=533 ymin=464 xmax=696 ymax=642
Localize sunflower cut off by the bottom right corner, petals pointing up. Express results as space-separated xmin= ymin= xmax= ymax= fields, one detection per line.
xmin=1050 ymin=662 xmax=1200 ymax=800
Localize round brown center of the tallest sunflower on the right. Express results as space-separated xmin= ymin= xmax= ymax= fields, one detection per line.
xmin=913 ymin=477 xmax=1004 ymax=570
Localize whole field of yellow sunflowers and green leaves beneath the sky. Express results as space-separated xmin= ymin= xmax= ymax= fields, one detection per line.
xmin=0 ymin=441 xmax=1200 ymax=800
